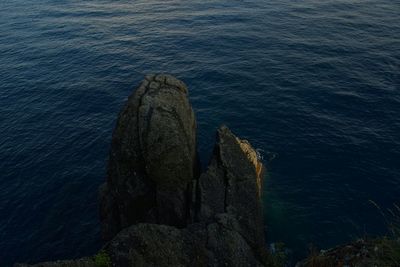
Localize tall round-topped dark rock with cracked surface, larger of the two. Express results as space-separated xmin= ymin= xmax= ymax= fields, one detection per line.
xmin=100 ymin=75 xmax=198 ymax=240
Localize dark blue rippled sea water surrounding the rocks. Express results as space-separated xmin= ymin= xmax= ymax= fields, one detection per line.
xmin=0 ymin=0 xmax=400 ymax=266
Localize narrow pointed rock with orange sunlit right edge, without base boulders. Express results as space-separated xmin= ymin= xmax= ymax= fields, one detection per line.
xmin=198 ymin=126 xmax=264 ymax=247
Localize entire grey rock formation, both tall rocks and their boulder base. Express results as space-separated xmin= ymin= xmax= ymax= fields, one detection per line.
xmin=15 ymin=75 xmax=266 ymax=267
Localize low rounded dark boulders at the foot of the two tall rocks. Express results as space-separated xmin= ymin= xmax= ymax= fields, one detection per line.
xmin=107 ymin=214 xmax=262 ymax=267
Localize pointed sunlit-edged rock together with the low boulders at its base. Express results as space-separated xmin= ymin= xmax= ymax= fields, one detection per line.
xmin=101 ymin=126 xmax=264 ymax=267
